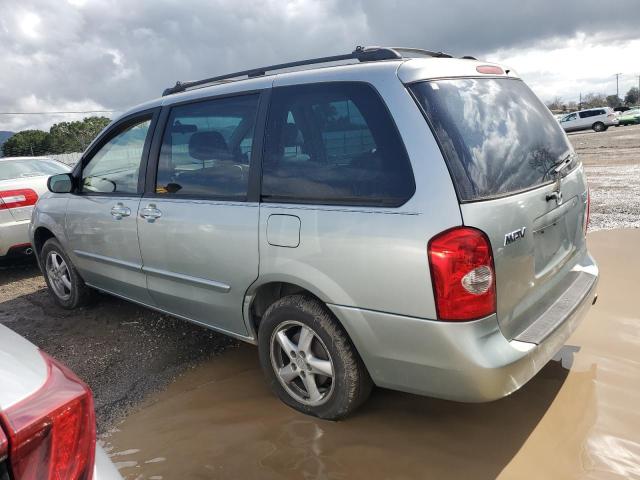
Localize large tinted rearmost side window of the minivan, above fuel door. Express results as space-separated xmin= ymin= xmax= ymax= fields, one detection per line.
xmin=262 ymin=82 xmax=415 ymax=206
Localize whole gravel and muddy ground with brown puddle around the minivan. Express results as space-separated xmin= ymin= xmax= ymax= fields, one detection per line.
xmin=0 ymin=126 xmax=640 ymax=480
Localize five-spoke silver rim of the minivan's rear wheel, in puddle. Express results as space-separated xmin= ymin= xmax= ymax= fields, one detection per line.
xmin=270 ymin=320 xmax=335 ymax=406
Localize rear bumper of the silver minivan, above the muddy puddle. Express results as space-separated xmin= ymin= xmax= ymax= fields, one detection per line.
xmin=329 ymin=255 xmax=598 ymax=402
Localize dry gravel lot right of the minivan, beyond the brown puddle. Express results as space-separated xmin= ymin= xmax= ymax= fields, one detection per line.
xmin=569 ymin=125 xmax=640 ymax=231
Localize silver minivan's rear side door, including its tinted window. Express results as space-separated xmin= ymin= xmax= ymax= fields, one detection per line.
xmin=138 ymin=94 xmax=260 ymax=336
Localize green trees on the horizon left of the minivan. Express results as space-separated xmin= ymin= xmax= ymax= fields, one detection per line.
xmin=2 ymin=117 xmax=111 ymax=157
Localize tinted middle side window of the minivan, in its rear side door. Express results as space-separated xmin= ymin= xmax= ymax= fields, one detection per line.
xmin=156 ymin=94 xmax=259 ymax=200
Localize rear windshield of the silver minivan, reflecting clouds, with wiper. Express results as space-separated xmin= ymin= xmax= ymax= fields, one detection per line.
xmin=409 ymin=78 xmax=573 ymax=202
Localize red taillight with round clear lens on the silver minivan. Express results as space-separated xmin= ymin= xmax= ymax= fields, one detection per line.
xmin=427 ymin=227 xmax=496 ymax=321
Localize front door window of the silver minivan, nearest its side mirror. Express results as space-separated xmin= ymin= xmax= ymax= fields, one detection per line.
xmin=82 ymin=118 xmax=151 ymax=193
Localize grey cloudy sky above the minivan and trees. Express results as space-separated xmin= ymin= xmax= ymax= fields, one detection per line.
xmin=0 ymin=0 xmax=640 ymax=131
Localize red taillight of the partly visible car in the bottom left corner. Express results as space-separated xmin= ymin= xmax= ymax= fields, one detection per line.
xmin=0 ymin=353 xmax=96 ymax=480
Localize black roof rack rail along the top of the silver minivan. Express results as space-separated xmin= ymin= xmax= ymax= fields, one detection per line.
xmin=162 ymin=46 xmax=452 ymax=97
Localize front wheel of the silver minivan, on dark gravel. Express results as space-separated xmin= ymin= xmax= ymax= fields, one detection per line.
xmin=40 ymin=238 xmax=94 ymax=310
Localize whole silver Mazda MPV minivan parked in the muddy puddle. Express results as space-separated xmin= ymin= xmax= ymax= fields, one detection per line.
xmin=31 ymin=47 xmax=598 ymax=419
